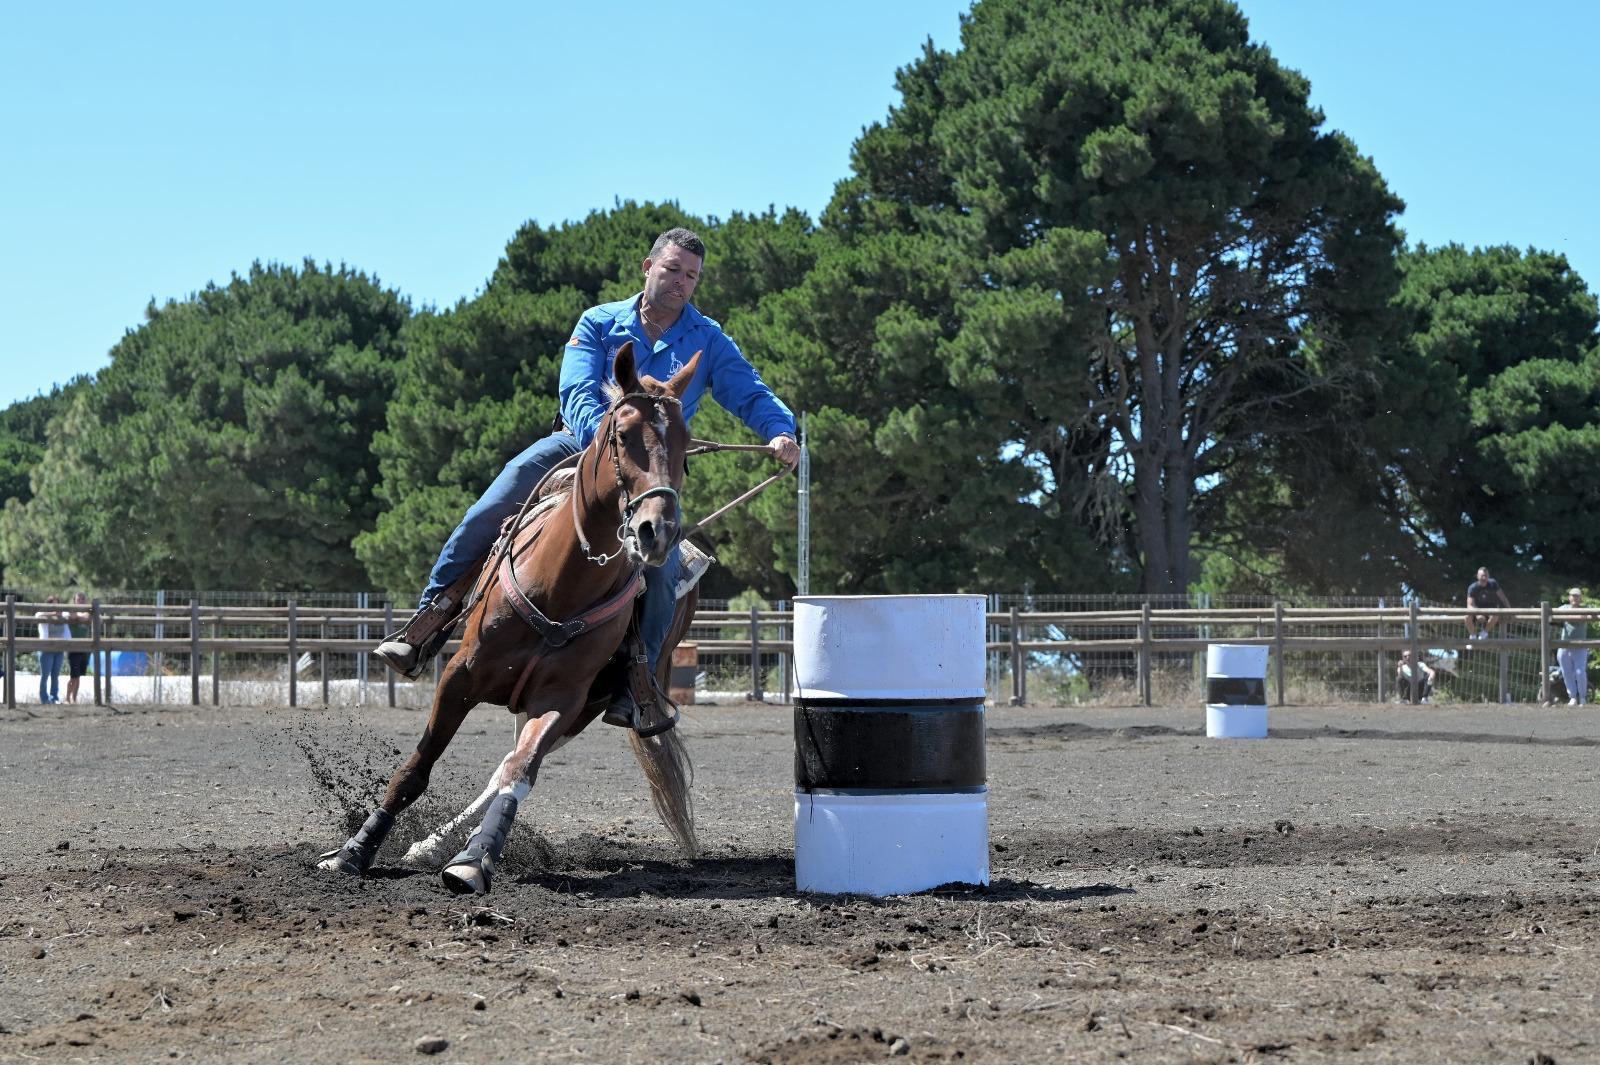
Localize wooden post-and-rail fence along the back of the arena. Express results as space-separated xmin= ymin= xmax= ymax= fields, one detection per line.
xmin=3 ymin=595 xmax=1600 ymax=708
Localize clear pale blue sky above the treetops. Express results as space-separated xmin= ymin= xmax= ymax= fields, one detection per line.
xmin=0 ymin=0 xmax=1600 ymax=405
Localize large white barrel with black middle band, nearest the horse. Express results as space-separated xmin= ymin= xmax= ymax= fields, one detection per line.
xmin=794 ymin=595 xmax=989 ymax=895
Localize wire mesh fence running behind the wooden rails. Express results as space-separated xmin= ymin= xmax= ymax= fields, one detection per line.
xmin=6 ymin=587 xmax=1580 ymax=707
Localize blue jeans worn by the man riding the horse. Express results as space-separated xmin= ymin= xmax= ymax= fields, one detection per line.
xmin=419 ymin=432 xmax=680 ymax=670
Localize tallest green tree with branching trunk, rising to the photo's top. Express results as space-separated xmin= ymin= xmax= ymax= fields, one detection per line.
xmin=806 ymin=0 xmax=1400 ymax=593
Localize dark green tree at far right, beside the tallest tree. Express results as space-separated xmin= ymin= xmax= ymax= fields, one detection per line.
xmin=1379 ymin=245 xmax=1600 ymax=598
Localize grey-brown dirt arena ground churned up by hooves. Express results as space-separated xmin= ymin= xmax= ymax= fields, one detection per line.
xmin=0 ymin=694 xmax=1600 ymax=1065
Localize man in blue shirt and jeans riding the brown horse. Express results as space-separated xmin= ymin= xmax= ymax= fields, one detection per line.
xmin=376 ymin=229 xmax=800 ymax=724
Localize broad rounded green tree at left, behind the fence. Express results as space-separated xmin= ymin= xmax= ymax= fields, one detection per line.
xmin=0 ymin=261 xmax=408 ymax=588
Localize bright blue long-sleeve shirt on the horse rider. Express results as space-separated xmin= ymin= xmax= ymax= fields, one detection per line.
xmin=560 ymin=296 xmax=795 ymax=448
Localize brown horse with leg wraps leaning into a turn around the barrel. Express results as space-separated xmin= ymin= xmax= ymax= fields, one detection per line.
xmin=318 ymin=342 xmax=699 ymax=892
